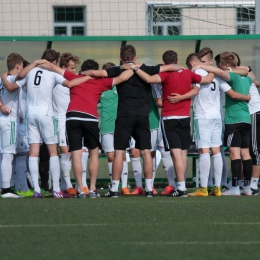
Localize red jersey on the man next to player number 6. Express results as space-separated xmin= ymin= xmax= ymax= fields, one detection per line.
xmin=64 ymin=70 xmax=113 ymax=117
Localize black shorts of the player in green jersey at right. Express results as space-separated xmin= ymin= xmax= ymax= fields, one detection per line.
xmin=224 ymin=123 xmax=251 ymax=148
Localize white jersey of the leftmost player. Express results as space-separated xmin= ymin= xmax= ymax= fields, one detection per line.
xmin=0 ymin=75 xmax=23 ymax=120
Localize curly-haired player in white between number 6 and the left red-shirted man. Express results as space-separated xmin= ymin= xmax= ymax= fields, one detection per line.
xmin=53 ymin=53 xmax=80 ymax=196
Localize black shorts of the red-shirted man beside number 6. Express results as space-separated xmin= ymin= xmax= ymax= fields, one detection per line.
xmin=66 ymin=112 xmax=101 ymax=152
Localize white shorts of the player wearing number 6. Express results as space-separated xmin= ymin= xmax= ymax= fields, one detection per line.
xmin=27 ymin=115 xmax=58 ymax=144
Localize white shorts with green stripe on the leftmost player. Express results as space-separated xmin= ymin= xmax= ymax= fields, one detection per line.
xmin=0 ymin=117 xmax=17 ymax=154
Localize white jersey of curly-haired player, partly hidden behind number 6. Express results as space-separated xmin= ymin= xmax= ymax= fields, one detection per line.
xmin=52 ymin=84 xmax=70 ymax=118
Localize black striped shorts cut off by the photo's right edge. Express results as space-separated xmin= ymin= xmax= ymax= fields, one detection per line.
xmin=250 ymin=112 xmax=260 ymax=165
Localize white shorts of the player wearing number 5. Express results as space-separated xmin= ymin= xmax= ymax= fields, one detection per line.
xmin=194 ymin=118 xmax=222 ymax=149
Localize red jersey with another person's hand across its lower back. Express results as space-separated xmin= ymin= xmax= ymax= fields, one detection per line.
xmin=158 ymin=70 xmax=202 ymax=117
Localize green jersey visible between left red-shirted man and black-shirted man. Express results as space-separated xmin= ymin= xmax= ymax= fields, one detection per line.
xmin=100 ymin=86 xmax=118 ymax=134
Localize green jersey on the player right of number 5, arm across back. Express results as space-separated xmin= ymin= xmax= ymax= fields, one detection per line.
xmin=225 ymin=72 xmax=252 ymax=124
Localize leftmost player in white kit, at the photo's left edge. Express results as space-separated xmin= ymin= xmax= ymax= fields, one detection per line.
xmin=0 ymin=53 xmax=26 ymax=198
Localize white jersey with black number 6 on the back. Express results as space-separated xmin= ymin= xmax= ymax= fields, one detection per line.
xmin=16 ymin=68 xmax=65 ymax=116
